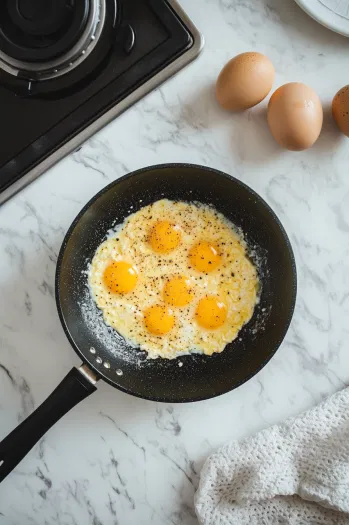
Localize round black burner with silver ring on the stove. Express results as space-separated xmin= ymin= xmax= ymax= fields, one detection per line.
xmin=0 ymin=0 xmax=106 ymax=81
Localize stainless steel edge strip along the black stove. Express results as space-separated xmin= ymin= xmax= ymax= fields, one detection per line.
xmin=0 ymin=0 xmax=204 ymax=205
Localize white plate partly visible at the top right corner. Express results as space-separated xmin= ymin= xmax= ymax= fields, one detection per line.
xmin=295 ymin=0 xmax=349 ymax=37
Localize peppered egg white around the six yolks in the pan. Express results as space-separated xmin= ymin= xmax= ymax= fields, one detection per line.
xmin=88 ymin=199 xmax=259 ymax=359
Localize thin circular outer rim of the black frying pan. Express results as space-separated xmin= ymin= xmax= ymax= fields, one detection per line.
xmin=55 ymin=162 xmax=297 ymax=404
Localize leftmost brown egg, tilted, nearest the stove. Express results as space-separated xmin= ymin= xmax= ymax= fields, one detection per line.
xmin=216 ymin=52 xmax=275 ymax=111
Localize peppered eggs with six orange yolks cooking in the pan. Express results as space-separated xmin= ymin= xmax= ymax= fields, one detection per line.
xmin=89 ymin=199 xmax=259 ymax=359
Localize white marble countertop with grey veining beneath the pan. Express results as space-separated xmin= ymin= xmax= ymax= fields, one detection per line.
xmin=0 ymin=0 xmax=349 ymax=525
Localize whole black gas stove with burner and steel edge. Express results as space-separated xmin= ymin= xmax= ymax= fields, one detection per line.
xmin=0 ymin=0 xmax=203 ymax=204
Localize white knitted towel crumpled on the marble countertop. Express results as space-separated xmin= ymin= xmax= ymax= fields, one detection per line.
xmin=195 ymin=388 xmax=349 ymax=525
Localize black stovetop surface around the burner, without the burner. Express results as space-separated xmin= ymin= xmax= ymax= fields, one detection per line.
xmin=0 ymin=0 xmax=201 ymax=202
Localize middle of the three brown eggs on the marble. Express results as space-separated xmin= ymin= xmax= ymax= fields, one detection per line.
xmin=268 ymin=82 xmax=323 ymax=151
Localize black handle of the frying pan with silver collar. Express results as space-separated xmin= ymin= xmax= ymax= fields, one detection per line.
xmin=0 ymin=365 xmax=97 ymax=483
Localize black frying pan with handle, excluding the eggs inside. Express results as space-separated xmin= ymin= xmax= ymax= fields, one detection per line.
xmin=0 ymin=164 xmax=296 ymax=481
